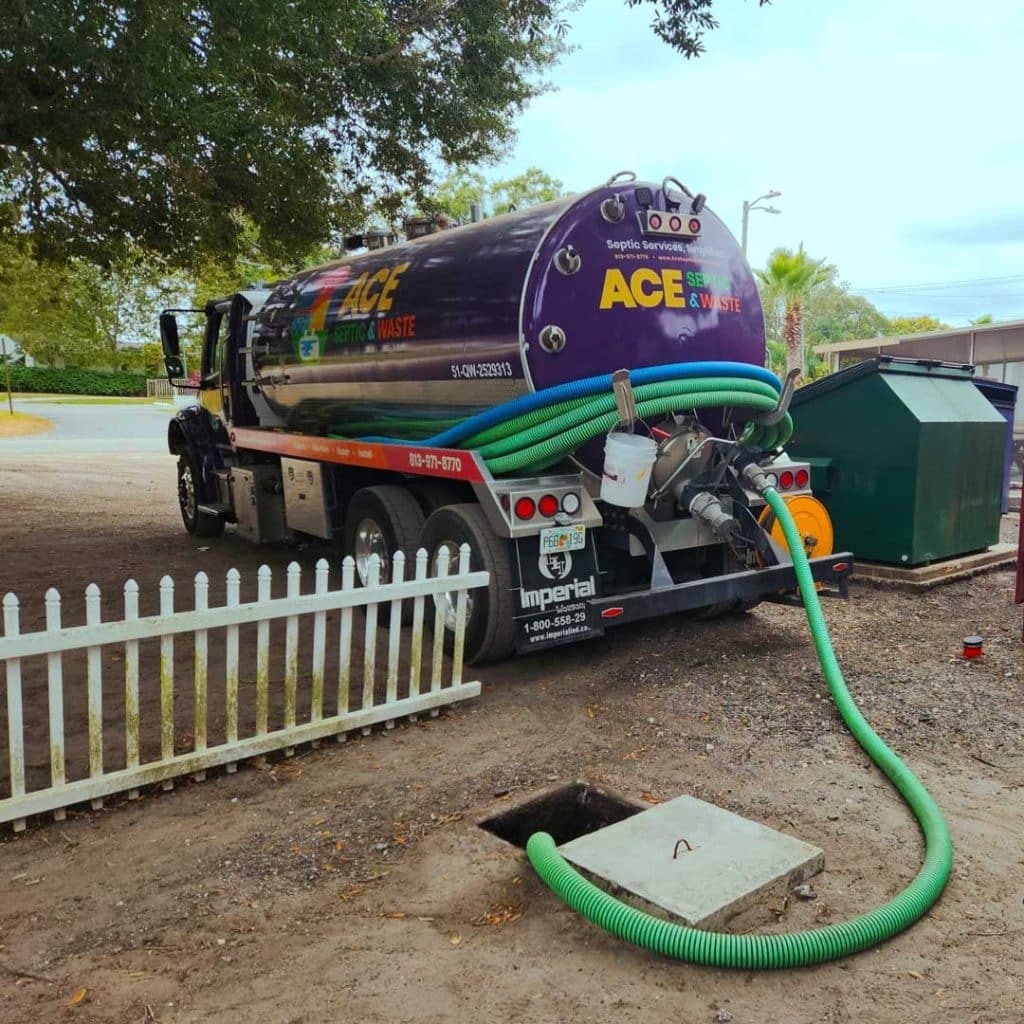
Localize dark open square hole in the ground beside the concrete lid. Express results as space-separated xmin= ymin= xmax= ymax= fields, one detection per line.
xmin=480 ymin=782 xmax=646 ymax=849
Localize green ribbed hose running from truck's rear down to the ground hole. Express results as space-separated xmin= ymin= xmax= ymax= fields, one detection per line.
xmin=526 ymin=487 xmax=952 ymax=969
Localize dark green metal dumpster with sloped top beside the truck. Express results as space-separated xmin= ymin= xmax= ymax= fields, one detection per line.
xmin=788 ymin=355 xmax=1006 ymax=565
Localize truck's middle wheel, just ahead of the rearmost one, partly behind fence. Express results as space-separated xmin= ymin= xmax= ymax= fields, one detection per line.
xmin=344 ymin=485 xmax=423 ymax=587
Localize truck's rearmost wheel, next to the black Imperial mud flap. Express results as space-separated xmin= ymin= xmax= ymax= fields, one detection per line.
xmin=423 ymin=502 xmax=515 ymax=665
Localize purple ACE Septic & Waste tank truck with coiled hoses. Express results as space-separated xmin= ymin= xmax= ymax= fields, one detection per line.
xmin=160 ymin=172 xmax=852 ymax=663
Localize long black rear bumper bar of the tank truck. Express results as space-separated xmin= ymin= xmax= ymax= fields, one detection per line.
xmin=590 ymin=551 xmax=853 ymax=627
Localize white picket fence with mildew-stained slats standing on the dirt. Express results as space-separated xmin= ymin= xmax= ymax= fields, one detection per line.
xmin=0 ymin=545 xmax=488 ymax=831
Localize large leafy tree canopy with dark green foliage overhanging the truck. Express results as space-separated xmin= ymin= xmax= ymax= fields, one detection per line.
xmin=0 ymin=0 xmax=766 ymax=266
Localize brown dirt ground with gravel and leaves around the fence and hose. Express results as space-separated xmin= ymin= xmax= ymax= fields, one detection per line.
xmin=0 ymin=450 xmax=1024 ymax=1024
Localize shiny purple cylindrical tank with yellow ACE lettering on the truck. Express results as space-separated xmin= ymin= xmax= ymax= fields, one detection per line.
xmin=256 ymin=175 xmax=765 ymax=464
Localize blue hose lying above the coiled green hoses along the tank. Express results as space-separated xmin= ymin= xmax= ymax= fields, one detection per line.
xmin=359 ymin=362 xmax=782 ymax=447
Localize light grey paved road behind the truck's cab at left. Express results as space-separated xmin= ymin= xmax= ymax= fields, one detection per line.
xmin=0 ymin=400 xmax=174 ymax=457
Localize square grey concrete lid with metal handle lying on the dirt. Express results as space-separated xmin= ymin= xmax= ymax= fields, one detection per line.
xmin=558 ymin=797 xmax=824 ymax=929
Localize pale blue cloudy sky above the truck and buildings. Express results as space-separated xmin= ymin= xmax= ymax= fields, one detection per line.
xmin=488 ymin=0 xmax=1024 ymax=325
